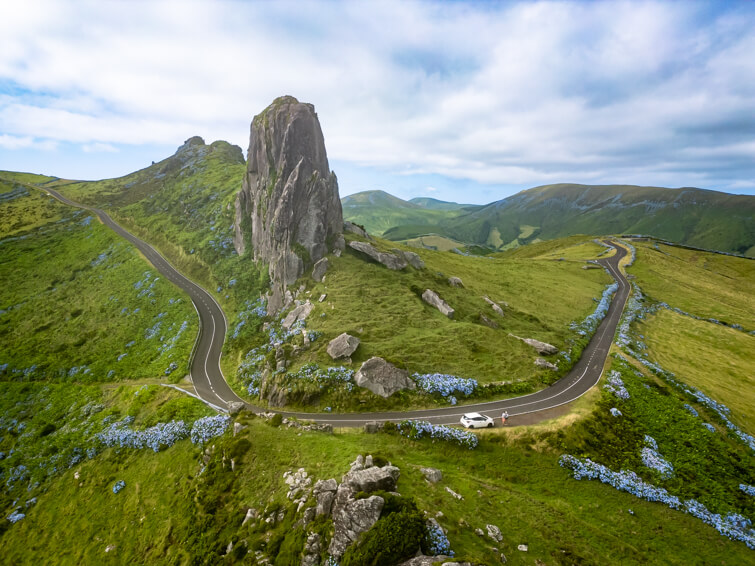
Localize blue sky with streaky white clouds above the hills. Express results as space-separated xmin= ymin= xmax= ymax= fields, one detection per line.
xmin=0 ymin=0 xmax=755 ymax=203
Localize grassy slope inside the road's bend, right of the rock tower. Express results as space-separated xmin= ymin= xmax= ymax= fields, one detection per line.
xmin=226 ymin=231 xmax=611 ymax=410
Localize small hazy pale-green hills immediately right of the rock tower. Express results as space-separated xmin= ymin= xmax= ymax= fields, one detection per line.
xmin=341 ymin=191 xmax=464 ymax=236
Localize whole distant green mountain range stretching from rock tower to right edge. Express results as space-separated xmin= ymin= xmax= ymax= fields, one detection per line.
xmin=344 ymin=183 xmax=755 ymax=257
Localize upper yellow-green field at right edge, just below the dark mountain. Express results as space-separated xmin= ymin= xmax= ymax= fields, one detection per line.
xmin=629 ymin=242 xmax=755 ymax=331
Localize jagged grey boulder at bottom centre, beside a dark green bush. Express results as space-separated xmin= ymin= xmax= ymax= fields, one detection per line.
xmin=328 ymin=486 xmax=385 ymax=558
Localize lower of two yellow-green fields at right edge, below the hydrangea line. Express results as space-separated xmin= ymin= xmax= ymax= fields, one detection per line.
xmin=637 ymin=309 xmax=755 ymax=434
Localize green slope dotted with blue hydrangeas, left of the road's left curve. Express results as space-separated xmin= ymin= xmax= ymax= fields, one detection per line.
xmin=0 ymin=189 xmax=197 ymax=382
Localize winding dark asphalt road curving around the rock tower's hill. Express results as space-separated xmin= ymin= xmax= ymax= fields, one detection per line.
xmin=31 ymin=185 xmax=629 ymax=427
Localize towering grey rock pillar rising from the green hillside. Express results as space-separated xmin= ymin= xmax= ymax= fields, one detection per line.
xmin=234 ymin=96 xmax=343 ymax=312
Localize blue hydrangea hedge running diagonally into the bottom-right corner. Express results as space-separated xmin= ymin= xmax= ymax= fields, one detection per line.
xmin=559 ymin=454 xmax=755 ymax=549
